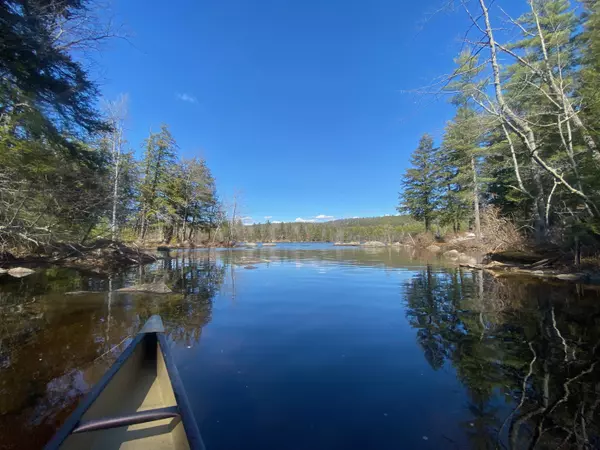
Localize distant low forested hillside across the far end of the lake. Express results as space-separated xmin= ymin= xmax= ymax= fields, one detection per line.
xmin=236 ymin=216 xmax=423 ymax=243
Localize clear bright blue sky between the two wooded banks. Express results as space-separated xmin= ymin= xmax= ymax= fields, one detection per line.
xmin=96 ymin=0 xmax=502 ymax=222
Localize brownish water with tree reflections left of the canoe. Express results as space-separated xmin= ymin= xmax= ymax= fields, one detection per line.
xmin=0 ymin=252 xmax=226 ymax=448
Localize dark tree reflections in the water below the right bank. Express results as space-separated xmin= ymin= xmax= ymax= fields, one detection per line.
xmin=405 ymin=265 xmax=600 ymax=449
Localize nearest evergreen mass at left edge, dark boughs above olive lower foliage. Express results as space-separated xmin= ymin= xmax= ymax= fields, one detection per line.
xmin=0 ymin=0 xmax=120 ymax=248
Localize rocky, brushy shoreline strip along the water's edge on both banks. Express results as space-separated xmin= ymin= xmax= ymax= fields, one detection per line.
xmin=0 ymin=240 xmax=600 ymax=285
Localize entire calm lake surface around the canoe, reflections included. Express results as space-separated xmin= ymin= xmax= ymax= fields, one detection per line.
xmin=0 ymin=244 xmax=600 ymax=450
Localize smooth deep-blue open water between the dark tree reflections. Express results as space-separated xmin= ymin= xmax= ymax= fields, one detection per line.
xmin=175 ymin=261 xmax=464 ymax=449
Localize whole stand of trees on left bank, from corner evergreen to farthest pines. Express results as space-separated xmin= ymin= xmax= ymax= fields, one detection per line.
xmin=0 ymin=0 xmax=221 ymax=251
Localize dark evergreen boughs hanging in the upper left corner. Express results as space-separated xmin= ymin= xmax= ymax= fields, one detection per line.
xmin=0 ymin=0 xmax=107 ymax=146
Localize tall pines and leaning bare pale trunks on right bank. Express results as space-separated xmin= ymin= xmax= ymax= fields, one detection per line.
xmin=398 ymin=0 xmax=600 ymax=250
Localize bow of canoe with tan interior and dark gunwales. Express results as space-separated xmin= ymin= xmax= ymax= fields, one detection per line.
xmin=45 ymin=316 xmax=204 ymax=450
